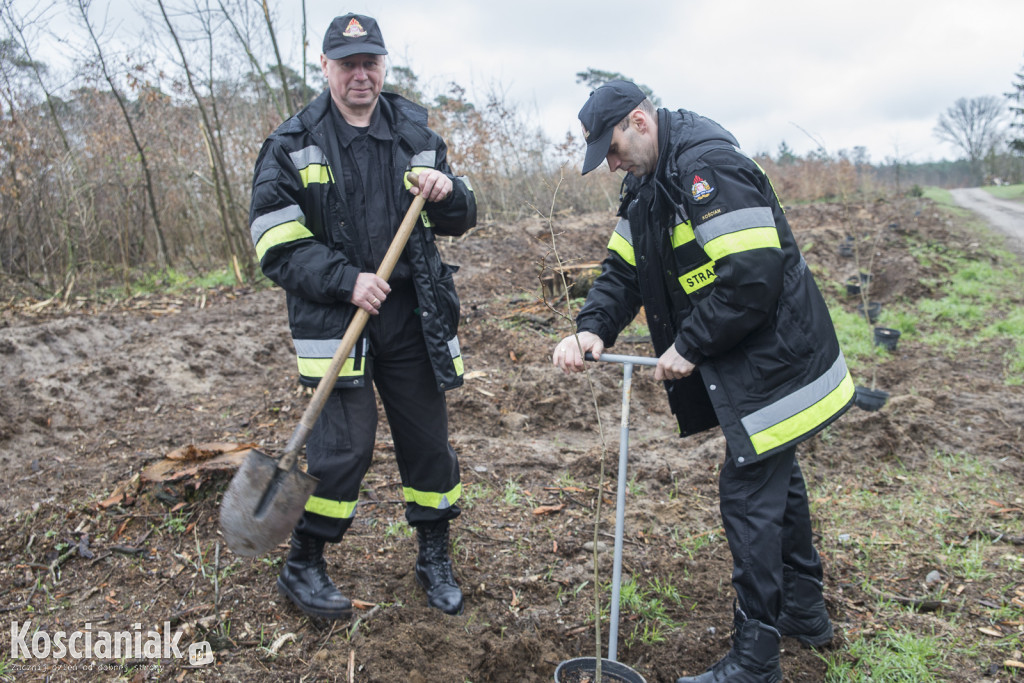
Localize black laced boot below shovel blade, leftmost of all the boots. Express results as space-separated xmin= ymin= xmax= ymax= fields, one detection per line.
xmin=278 ymin=531 xmax=352 ymax=620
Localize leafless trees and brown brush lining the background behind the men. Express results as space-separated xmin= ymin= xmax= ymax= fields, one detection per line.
xmin=6 ymin=0 xmax=1024 ymax=301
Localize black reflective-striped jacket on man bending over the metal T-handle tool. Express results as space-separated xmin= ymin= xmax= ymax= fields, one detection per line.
xmin=578 ymin=110 xmax=854 ymax=466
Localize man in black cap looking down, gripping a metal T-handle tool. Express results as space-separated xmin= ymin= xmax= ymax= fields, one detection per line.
xmin=553 ymin=81 xmax=854 ymax=683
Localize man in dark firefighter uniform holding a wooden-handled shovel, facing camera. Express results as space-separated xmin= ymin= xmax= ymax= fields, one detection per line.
xmin=250 ymin=14 xmax=476 ymax=618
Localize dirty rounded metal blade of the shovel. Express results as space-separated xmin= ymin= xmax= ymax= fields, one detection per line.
xmin=220 ymin=450 xmax=316 ymax=557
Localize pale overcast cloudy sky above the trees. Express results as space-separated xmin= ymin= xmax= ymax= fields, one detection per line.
xmin=14 ymin=0 xmax=1024 ymax=163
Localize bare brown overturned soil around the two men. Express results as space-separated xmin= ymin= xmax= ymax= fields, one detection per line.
xmin=0 ymin=194 xmax=1024 ymax=683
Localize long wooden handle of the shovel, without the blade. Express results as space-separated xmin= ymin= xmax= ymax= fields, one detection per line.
xmin=278 ymin=179 xmax=426 ymax=470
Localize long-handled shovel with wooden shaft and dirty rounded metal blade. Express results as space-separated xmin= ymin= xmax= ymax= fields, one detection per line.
xmin=220 ymin=180 xmax=425 ymax=557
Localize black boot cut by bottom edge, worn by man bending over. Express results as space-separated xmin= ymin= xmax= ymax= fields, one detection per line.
xmin=676 ymin=609 xmax=782 ymax=683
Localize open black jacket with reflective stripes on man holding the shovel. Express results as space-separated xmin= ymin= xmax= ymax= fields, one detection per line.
xmin=249 ymin=90 xmax=476 ymax=390
